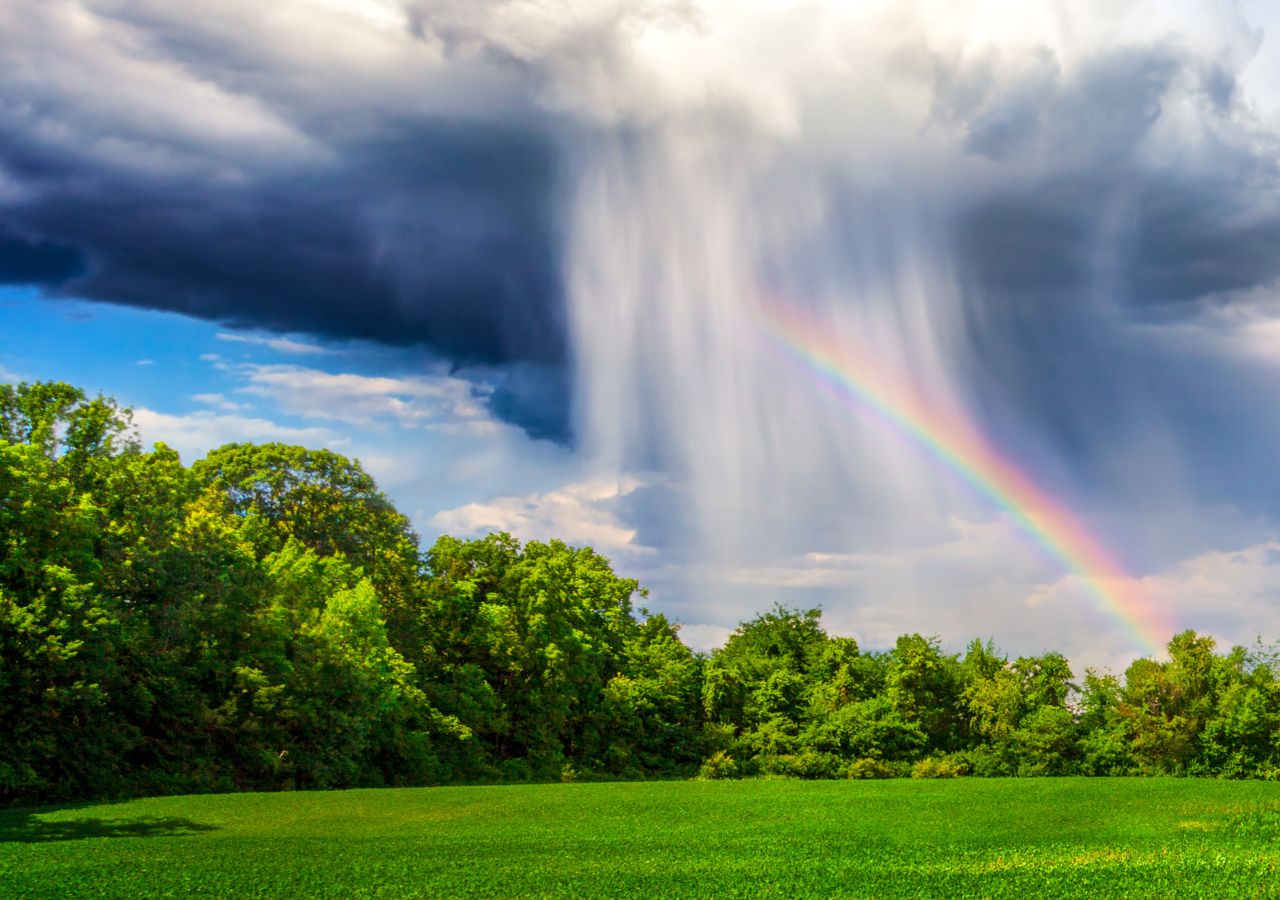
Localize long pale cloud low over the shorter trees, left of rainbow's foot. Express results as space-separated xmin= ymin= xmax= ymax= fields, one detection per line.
xmin=641 ymin=516 xmax=1167 ymax=673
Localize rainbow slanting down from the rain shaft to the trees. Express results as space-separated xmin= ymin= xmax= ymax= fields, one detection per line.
xmin=759 ymin=303 xmax=1174 ymax=654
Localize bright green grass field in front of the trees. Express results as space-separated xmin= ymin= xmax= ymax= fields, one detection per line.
xmin=0 ymin=778 xmax=1280 ymax=900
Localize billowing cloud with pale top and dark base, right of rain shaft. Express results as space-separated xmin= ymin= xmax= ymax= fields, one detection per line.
xmin=952 ymin=42 xmax=1280 ymax=307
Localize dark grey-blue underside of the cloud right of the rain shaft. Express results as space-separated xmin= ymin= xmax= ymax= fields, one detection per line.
xmin=957 ymin=175 xmax=1280 ymax=308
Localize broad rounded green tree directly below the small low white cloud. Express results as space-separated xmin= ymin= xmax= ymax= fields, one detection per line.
xmin=422 ymin=535 xmax=650 ymax=777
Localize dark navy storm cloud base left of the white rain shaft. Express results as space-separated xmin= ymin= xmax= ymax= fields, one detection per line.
xmin=0 ymin=122 xmax=563 ymax=364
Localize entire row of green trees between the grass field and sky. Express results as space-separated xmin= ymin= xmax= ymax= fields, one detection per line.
xmin=0 ymin=383 xmax=1280 ymax=803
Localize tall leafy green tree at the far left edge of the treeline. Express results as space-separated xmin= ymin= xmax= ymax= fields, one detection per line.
xmin=0 ymin=383 xmax=133 ymax=800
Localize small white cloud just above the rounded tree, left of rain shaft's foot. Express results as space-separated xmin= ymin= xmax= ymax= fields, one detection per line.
xmin=430 ymin=478 xmax=648 ymax=553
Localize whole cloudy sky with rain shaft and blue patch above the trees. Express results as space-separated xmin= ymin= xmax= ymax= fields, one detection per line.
xmin=0 ymin=0 xmax=1280 ymax=668
